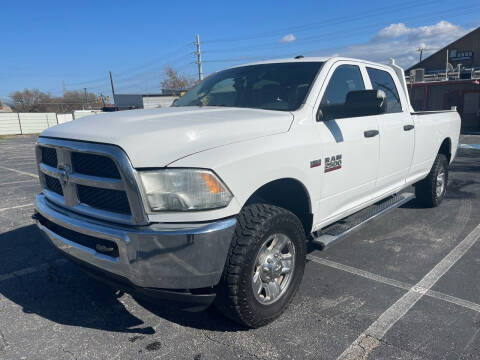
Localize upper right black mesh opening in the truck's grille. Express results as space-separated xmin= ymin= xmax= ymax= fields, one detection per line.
xmin=72 ymin=152 xmax=120 ymax=179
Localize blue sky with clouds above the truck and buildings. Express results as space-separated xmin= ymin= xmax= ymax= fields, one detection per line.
xmin=0 ymin=0 xmax=480 ymax=101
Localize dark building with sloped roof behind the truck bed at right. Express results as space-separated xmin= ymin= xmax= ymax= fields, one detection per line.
xmin=406 ymin=28 xmax=480 ymax=132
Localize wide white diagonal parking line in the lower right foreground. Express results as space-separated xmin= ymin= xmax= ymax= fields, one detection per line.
xmin=338 ymin=224 xmax=480 ymax=359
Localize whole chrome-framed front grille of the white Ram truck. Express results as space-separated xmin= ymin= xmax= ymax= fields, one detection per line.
xmin=36 ymin=137 xmax=148 ymax=225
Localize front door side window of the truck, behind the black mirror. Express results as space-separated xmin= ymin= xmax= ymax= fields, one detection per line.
xmin=319 ymin=65 xmax=365 ymax=120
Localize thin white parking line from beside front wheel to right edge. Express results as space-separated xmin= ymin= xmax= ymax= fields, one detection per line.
xmin=307 ymin=255 xmax=480 ymax=313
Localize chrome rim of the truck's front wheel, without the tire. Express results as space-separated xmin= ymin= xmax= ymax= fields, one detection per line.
xmin=252 ymin=233 xmax=295 ymax=305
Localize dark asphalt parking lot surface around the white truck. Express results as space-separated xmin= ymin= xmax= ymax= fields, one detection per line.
xmin=0 ymin=136 xmax=480 ymax=360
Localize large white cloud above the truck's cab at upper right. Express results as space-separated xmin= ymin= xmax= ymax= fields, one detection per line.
xmin=314 ymin=21 xmax=470 ymax=67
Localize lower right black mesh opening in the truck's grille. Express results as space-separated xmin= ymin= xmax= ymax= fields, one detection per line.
xmin=77 ymin=185 xmax=130 ymax=215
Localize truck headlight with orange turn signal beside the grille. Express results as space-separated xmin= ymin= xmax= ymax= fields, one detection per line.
xmin=140 ymin=169 xmax=233 ymax=211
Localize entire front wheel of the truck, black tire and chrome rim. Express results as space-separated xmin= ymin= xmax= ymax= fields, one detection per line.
xmin=215 ymin=204 xmax=306 ymax=328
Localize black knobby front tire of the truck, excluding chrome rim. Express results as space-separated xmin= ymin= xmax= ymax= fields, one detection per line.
xmin=215 ymin=203 xmax=306 ymax=328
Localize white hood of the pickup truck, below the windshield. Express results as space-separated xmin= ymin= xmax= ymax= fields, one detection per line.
xmin=41 ymin=107 xmax=293 ymax=168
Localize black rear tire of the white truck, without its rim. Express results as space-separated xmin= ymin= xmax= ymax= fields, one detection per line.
xmin=415 ymin=154 xmax=448 ymax=207
